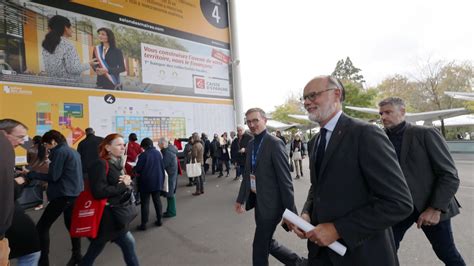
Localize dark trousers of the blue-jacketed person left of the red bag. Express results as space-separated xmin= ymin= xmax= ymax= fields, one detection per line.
xmin=36 ymin=197 xmax=81 ymax=266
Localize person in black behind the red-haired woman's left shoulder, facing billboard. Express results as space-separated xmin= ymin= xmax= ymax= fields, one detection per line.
xmin=77 ymin=127 xmax=104 ymax=178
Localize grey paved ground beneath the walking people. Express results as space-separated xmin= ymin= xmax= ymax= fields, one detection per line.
xmin=18 ymin=154 xmax=474 ymax=266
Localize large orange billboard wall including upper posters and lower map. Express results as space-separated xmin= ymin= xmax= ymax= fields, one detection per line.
xmin=0 ymin=0 xmax=235 ymax=160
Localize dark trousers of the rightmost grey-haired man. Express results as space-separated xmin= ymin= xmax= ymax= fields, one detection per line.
xmin=392 ymin=209 xmax=466 ymax=266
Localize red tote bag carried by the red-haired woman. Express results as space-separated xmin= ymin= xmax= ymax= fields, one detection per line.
xmin=69 ymin=161 xmax=109 ymax=238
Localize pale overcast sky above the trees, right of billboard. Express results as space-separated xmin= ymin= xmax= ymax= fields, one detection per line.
xmin=234 ymin=0 xmax=474 ymax=111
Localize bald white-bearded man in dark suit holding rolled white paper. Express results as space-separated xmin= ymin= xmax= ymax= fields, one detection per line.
xmin=290 ymin=76 xmax=412 ymax=266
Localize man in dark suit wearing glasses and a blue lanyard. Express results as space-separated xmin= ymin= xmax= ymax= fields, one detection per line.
xmin=235 ymin=108 xmax=303 ymax=266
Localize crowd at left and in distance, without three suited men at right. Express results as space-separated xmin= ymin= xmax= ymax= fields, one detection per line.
xmin=0 ymin=119 xmax=304 ymax=265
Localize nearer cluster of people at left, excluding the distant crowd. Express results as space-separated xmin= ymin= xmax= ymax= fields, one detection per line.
xmin=0 ymin=123 xmax=193 ymax=266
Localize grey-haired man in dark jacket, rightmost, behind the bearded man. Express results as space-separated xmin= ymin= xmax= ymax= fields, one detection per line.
xmin=379 ymin=97 xmax=466 ymax=265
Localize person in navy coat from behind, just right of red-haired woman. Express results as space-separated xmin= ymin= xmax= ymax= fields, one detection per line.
xmin=133 ymin=138 xmax=165 ymax=231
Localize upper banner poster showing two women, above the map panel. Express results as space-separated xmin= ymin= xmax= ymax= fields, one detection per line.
xmin=0 ymin=0 xmax=233 ymax=99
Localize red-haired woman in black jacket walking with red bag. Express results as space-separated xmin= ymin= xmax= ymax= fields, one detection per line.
xmin=80 ymin=134 xmax=139 ymax=265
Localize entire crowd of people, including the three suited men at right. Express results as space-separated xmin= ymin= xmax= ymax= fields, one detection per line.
xmin=0 ymin=76 xmax=466 ymax=266
